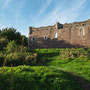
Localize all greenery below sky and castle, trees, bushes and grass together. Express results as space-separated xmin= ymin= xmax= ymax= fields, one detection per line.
xmin=0 ymin=28 xmax=90 ymax=90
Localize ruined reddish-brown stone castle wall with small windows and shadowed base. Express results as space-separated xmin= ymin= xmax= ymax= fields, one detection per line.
xmin=28 ymin=19 xmax=90 ymax=49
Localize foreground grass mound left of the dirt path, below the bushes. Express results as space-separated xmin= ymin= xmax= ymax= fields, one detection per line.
xmin=0 ymin=66 xmax=82 ymax=90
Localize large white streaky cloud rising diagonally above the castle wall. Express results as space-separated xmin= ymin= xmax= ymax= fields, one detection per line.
xmin=34 ymin=0 xmax=87 ymax=26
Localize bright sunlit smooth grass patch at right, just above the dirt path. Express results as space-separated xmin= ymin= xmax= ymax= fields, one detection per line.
xmin=49 ymin=58 xmax=90 ymax=81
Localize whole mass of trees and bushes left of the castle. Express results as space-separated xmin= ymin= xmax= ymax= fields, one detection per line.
xmin=0 ymin=28 xmax=37 ymax=66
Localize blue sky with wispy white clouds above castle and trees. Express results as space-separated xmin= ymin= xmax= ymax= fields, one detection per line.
xmin=0 ymin=0 xmax=90 ymax=36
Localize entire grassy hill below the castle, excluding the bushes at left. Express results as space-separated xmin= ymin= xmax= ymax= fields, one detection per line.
xmin=0 ymin=49 xmax=90 ymax=90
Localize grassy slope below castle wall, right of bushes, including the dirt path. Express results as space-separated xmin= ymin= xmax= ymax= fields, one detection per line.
xmin=36 ymin=49 xmax=90 ymax=90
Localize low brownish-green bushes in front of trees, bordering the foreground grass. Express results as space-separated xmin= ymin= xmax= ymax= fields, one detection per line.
xmin=0 ymin=52 xmax=36 ymax=66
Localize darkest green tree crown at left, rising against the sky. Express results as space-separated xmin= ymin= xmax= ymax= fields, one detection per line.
xmin=0 ymin=28 xmax=27 ymax=45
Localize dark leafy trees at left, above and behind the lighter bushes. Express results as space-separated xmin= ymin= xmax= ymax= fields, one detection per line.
xmin=0 ymin=27 xmax=27 ymax=50
